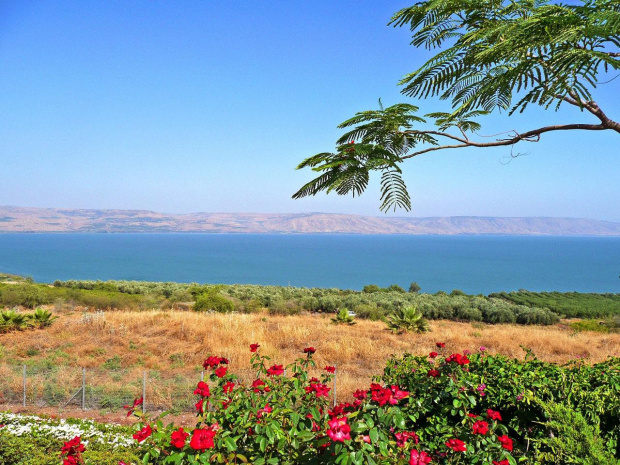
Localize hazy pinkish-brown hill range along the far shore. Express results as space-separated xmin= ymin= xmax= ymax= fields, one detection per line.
xmin=0 ymin=207 xmax=620 ymax=236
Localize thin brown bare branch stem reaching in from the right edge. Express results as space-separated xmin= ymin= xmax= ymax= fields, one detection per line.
xmin=401 ymin=121 xmax=608 ymax=160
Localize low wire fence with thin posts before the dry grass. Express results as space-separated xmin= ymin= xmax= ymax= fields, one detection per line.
xmin=0 ymin=364 xmax=337 ymax=413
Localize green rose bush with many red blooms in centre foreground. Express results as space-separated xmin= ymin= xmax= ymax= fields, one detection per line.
xmin=133 ymin=344 xmax=516 ymax=465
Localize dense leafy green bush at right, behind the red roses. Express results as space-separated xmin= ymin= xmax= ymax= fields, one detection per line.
xmin=381 ymin=345 xmax=620 ymax=458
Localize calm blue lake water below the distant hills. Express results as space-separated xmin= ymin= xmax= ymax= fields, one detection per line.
xmin=0 ymin=234 xmax=620 ymax=294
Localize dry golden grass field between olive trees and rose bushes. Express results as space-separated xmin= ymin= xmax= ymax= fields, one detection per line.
xmin=0 ymin=311 xmax=620 ymax=406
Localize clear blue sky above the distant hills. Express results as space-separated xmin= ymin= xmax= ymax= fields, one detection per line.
xmin=0 ymin=0 xmax=620 ymax=221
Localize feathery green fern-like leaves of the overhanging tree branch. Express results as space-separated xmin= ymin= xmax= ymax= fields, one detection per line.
xmin=293 ymin=0 xmax=620 ymax=212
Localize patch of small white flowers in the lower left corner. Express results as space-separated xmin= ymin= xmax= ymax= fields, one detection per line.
xmin=0 ymin=412 xmax=136 ymax=448
